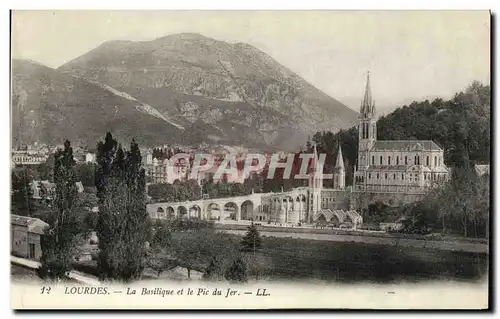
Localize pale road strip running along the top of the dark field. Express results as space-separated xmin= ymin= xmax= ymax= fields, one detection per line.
xmin=221 ymin=229 xmax=489 ymax=253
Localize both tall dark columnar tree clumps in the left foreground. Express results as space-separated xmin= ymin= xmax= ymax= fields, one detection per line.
xmin=40 ymin=133 xmax=151 ymax=281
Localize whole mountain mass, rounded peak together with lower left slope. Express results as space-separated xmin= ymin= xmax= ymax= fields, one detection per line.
xmin=12 ymin=33 xmax=357 ymax=150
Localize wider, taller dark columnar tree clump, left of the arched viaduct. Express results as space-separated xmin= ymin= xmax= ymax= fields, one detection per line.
xmin=95 ymin=133 xmax=151 ymax=281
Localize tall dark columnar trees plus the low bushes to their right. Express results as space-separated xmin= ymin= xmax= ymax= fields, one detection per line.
xmin=39 ymin=133 xmax=261 ymax=282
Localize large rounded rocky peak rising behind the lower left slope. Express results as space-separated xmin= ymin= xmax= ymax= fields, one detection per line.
xmin=57 ymin=33 xmax=357 ymax=149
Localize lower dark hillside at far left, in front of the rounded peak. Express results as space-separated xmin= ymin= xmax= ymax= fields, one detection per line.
xmin=12 ymin=60 xmax=183 ymax=146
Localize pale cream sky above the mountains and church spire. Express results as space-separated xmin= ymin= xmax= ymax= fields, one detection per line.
xmin=12 ymin=11 xmax=490 ymax=112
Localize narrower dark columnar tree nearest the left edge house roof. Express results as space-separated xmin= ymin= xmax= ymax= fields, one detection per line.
xmin=39 ymin=141 xmax=82 ymax=279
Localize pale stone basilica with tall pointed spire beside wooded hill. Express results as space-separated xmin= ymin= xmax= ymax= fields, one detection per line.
xmin=351 ymin=73 xmax=448 ymax=208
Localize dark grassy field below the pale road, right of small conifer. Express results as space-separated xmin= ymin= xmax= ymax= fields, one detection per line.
xmin=252 ymin=237 xmax=488 ymax=283
